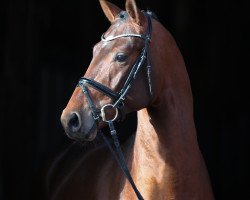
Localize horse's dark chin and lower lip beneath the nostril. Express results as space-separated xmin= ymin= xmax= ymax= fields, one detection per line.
xmin=66 ymin=123 xmax=98 ymax=142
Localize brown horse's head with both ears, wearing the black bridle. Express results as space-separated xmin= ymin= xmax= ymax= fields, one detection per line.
xmin=61 ymin=0 xmax=165 ymax=141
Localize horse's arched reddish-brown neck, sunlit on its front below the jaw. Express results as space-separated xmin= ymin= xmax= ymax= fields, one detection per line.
xmin=120 ymin=21 xmax=213 ymax=200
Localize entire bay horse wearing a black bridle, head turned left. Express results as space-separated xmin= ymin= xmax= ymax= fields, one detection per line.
xmin=50 ymin=0 xmax=214 ymax=200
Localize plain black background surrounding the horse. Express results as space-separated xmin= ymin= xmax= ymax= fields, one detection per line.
xmin=0 ymin=0 xmax=250 ymax=200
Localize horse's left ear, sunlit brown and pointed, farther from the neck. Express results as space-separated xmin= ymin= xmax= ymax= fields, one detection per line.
xmin=99 ymin=0 xmax=121 ymax=22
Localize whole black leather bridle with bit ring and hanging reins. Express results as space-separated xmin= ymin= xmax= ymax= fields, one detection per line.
xmin=78 ymin=12 xmax=153 ymax=200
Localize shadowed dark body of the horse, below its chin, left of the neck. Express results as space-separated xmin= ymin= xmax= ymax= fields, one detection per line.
xmin=50 ymin=145 xmax=129 ymax=200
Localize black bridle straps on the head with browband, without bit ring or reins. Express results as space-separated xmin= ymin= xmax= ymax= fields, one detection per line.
xmin=78 ymin=12 xmax=153 ymax=124
